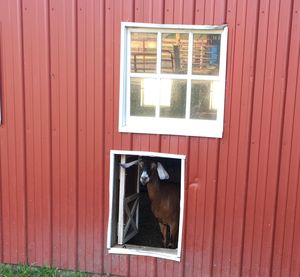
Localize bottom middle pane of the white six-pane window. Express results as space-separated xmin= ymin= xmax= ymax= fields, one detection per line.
xmin=160 ymin=79 xmax=187 ymax=118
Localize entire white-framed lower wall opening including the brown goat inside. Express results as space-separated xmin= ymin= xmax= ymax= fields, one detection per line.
xmin=107 ymin=150 xmax=185 ymax=261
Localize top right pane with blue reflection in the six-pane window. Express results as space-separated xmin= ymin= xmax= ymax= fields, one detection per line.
xmin=193 ymin=34 xmax=221 ymax=75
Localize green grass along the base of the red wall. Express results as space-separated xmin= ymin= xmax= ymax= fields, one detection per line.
xmin=0 ymin=264 xmax=111 ymax=277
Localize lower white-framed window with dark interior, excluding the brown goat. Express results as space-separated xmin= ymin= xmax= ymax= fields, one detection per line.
xmin=107 ymin=150 xmax=185 ymax=261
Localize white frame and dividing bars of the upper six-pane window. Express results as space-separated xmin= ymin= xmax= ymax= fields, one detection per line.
xmin=119 ymin=22 xmax=228 ymax=138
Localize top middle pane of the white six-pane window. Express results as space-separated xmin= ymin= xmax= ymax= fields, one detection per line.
xmin=161 ymin=33 xmax=189 ymax=74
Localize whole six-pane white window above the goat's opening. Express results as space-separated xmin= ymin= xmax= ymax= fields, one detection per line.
xmin=119 ymin=23 xmax=227 ymax=137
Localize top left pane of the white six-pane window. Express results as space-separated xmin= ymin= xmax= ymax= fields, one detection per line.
xmin=130 ymin=33 xmax=157 ymax=73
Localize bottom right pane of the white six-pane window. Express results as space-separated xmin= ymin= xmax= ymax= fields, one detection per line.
xmin=190 ymin=81 xmax=218 ymax=120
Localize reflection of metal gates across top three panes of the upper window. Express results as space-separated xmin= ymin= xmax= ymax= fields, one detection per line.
xmin=131 ymin=33 xmax=220 ymax=75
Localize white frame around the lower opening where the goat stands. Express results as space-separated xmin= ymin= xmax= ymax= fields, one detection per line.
xmin=107 ymin=150 xmax=186 ymax=261
